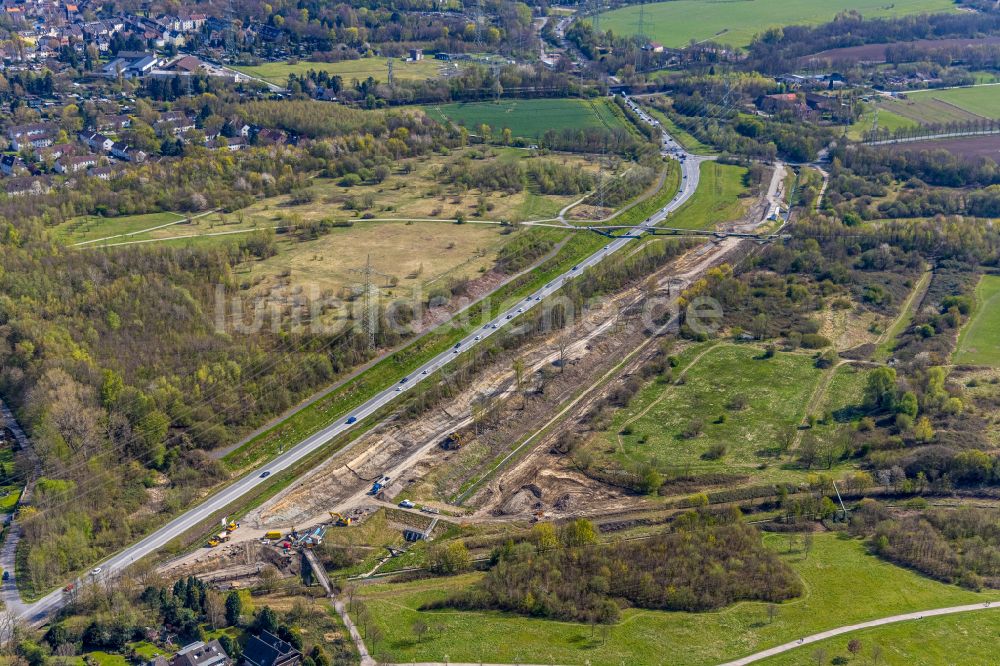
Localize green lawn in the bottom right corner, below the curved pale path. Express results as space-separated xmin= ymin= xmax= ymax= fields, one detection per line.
xmin=760 ymin=609 xmax=1000 ymax=666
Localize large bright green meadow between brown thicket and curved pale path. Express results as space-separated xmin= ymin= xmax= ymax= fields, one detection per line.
xmin=363 ymin=534 xmax=996 ymax=666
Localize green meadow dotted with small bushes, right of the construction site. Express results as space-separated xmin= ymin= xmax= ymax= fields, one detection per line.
xmin=604 ymin=343 xmax=821 ymax=475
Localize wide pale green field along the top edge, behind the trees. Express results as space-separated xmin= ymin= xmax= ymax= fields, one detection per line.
xmin=588 ymin=0 xmax=955 ymax=47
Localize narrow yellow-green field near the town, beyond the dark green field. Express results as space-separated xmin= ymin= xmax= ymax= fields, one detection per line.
xmin=233 ymin=58 xmax=446 ymax=86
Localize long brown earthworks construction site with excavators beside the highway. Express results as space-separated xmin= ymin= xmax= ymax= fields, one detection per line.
xmin=158 ymin=165 xmax=785 ymax=593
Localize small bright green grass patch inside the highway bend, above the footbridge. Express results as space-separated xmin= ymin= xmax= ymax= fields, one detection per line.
xmin=663 ymin=161 xmax=749 ymax=229
